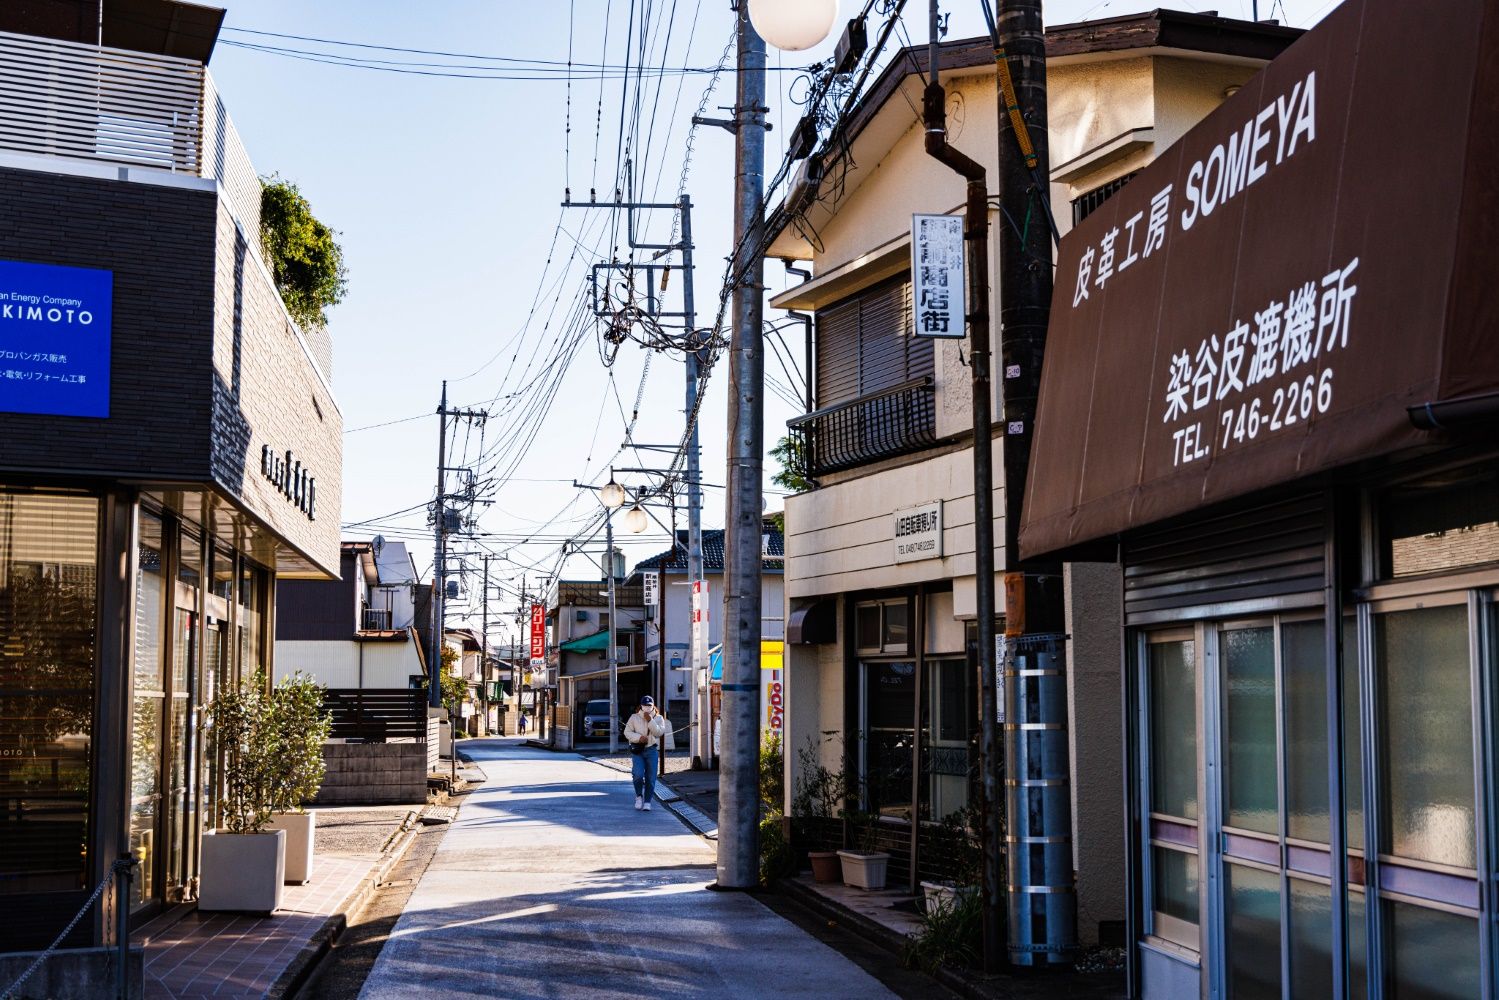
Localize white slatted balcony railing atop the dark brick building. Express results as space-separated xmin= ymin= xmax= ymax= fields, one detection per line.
xmin=0 ymin=31 xmax=261 ymax=262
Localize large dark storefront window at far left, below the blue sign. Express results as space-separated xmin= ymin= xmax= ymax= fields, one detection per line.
xmin=0 ymin=493 xmax=99 ymax=895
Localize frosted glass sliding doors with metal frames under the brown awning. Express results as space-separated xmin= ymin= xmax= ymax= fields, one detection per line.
xmin=1130 ymin=474 xmax=1499 ymax=1000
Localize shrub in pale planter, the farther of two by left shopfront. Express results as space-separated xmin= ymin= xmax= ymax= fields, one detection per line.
xmin=265 ymin=670 xmax=333 ymax=885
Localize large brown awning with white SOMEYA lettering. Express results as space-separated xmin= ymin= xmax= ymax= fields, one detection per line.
xmin=1019 ymin=0 xmax=1499 ymax=558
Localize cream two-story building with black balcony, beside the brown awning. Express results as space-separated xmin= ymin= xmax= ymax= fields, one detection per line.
xmin=767 ymin=10 xmax=1298 ymax=943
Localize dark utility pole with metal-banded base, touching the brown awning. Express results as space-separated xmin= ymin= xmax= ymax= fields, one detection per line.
xmin=985 ymin=0 xmax=1078 ymax=967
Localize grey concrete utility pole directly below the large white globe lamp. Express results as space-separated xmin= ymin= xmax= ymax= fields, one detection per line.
xmin=716 ymin=3 xmax=769 ymax=889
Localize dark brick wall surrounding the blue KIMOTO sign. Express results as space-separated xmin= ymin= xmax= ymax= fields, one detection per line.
xmin=0 ymin=168 xmax=217 ymax=479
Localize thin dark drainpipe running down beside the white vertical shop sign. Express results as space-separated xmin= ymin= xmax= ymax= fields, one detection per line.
xmin=922 ymin=0 xmax=1004 ymax=972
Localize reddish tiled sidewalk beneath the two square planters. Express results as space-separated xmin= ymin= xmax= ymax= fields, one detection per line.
xmin=130 ymin=805 xmax=421 ymax=1000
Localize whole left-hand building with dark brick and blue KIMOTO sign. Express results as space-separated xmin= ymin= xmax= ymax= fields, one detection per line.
xmin=0 ymin=0 xmax=342 ymax=971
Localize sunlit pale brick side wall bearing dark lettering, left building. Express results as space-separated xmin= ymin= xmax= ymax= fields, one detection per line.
xmin=213 ymin=207 xmax=343 ymax=570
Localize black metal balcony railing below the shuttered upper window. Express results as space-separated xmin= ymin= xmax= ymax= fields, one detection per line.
xmin=785 ymin=375 xmax=937 ymax=481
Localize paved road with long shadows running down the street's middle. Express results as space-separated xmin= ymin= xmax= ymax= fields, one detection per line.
xmin=360 ymin=739 xmax=895 ymax=1000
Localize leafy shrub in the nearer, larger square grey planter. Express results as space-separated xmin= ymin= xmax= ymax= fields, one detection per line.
xmin=198 ymin=673 xmax=286 ymax=913
